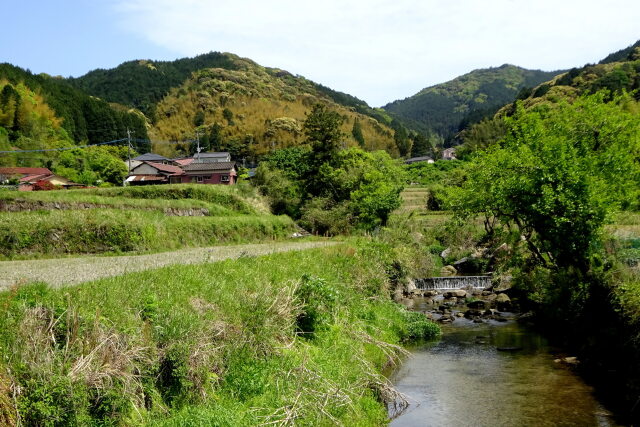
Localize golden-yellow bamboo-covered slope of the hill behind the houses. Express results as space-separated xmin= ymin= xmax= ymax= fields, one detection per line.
xmin=150 ymin=57 xmax=397 ymax=158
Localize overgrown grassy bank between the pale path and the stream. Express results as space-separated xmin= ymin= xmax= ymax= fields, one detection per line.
xmin=0 ymin=243 xmax=439 ymax=426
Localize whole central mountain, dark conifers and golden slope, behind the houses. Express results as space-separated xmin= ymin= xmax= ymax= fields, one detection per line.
xmin=70 ymin=52 xmax=399 ymax=158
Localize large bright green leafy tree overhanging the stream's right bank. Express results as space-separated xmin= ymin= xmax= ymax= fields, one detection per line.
xmin=456 ymin=93 xmax=640 ymax=277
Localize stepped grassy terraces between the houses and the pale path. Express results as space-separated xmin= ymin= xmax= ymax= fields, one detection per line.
xmin=0 ymin=185 xmax=295 ymax=259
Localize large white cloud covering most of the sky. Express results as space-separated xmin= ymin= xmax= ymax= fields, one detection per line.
xmin=113 ymin=0 xmax=640 ymax=105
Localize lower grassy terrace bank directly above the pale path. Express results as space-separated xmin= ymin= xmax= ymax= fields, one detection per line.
xmin=0 ymin=209 xmax=295 ymax=257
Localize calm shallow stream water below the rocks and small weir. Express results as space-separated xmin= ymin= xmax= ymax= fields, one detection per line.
xmin=391 ymin=301 xmax=618 ymax=427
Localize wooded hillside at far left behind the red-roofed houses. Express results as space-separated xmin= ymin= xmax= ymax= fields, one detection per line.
xmin=0 ymin=64 xmax=149 ymax=185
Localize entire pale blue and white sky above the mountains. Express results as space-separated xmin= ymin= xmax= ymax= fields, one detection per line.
xmin=0 ymin=0 xmax=640 ymax=107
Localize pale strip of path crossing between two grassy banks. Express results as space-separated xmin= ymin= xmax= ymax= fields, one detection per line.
xmin=0 ymin=242 xmax=336 ymax=290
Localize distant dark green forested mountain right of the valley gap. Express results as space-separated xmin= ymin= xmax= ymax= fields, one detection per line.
xmin=383 ymin=64 xmax=561 ymax=140
